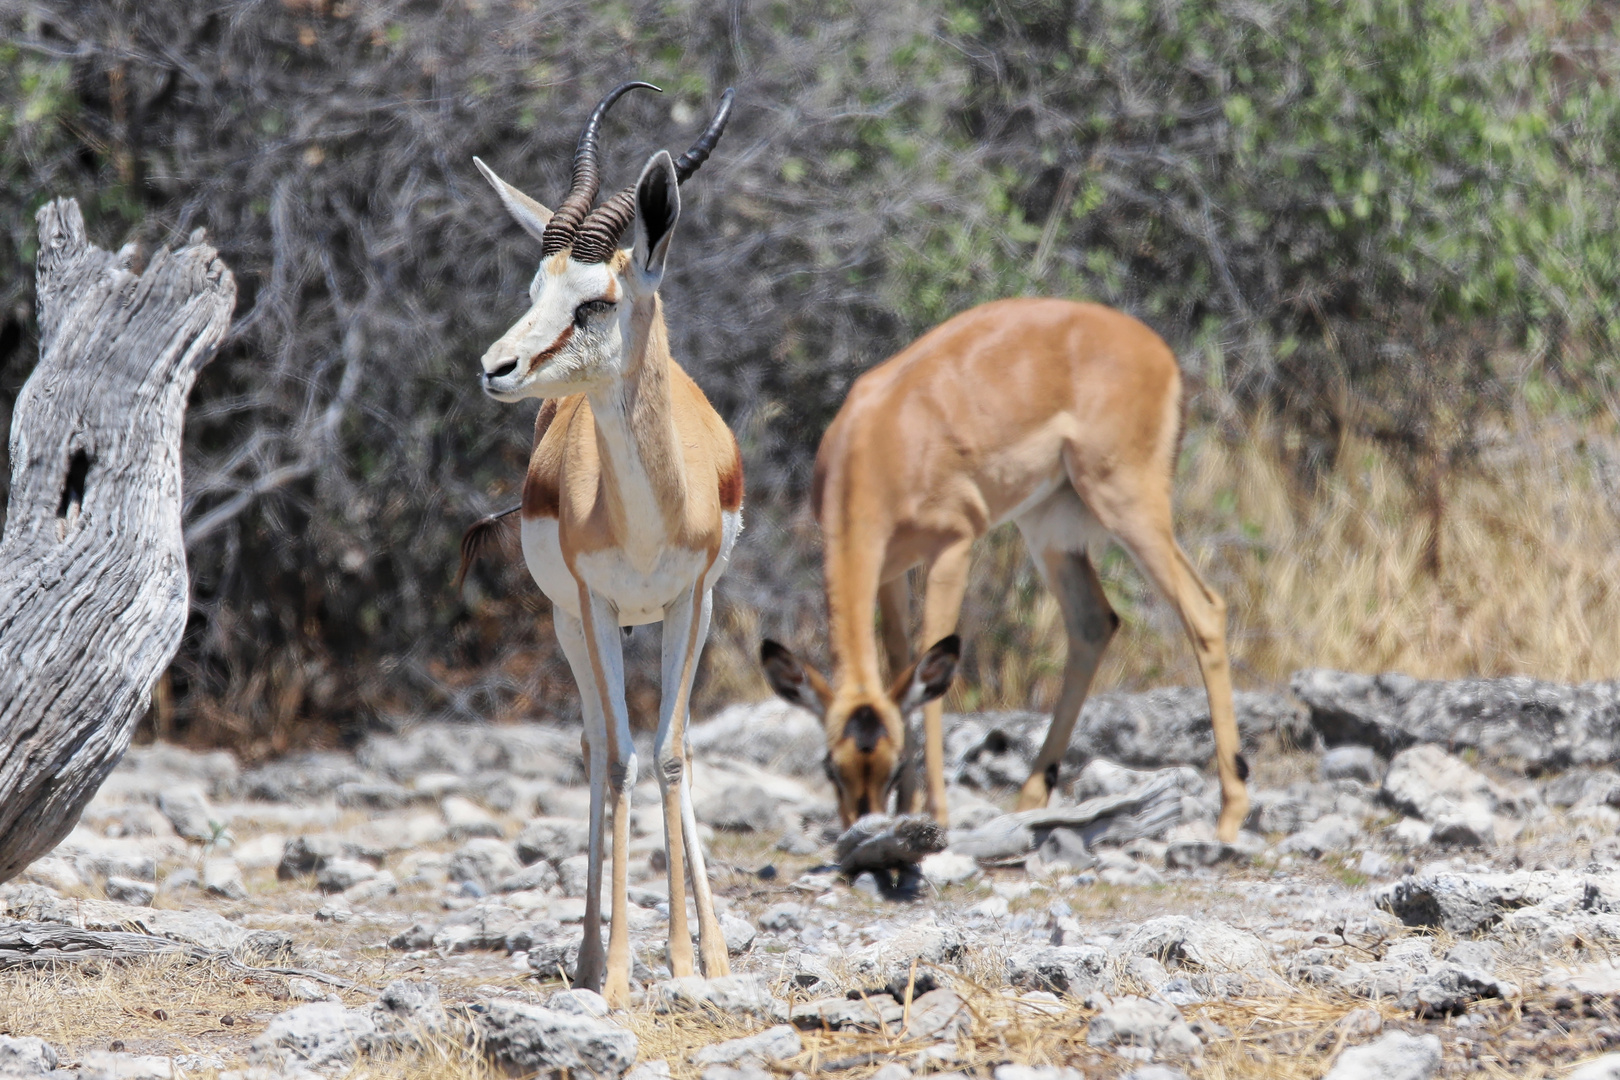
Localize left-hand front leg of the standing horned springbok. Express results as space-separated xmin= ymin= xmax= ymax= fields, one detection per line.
xmin=580 ymin=585 xmax=637 ymax=1009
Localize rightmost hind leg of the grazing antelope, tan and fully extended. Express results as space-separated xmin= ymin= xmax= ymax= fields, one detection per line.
xmin=1069 ymin=463 xmax=1249 ymax=842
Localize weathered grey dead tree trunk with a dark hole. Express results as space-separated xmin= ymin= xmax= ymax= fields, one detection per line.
xmin=0 ymin=199 xmax=237 ymax=881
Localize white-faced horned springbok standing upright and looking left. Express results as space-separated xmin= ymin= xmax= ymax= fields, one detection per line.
xmin=462 ymin=83 xmax=742 ymax=1006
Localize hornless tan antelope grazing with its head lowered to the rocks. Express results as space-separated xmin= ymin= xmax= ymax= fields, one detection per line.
xmin=761 ymin=300 xmax=1249 ymax=842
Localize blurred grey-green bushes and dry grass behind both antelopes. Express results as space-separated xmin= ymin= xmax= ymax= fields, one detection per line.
xmin=0 ymin=0 xmax=1620 ymax=755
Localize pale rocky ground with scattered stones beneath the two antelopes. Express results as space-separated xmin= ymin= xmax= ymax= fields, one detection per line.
xmin=0 ymin=672 xmax=1620 ymax=1080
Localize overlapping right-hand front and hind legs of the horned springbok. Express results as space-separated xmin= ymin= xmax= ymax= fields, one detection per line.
xmin=654 ymin=583 xmax=731 ymax=978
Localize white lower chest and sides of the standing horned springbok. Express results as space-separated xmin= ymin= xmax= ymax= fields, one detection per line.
xmin=522 ymin=512 xmax=742 ymax=627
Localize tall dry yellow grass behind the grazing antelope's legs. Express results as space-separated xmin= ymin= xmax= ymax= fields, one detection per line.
xmin=706 ymin=421 xmax=1620 ymax=709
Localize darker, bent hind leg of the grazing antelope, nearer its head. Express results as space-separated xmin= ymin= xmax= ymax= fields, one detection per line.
xmin=1017 ymin=533 xmax=1119 ymax=810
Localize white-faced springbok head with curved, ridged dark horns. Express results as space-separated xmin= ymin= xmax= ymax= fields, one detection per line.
xmin=473 ymin=83 xmax=734 ymax=402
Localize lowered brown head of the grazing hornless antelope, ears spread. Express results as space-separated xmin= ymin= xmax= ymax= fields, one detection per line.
xmin=760 ymin=633 xmax=962 ymax=827
